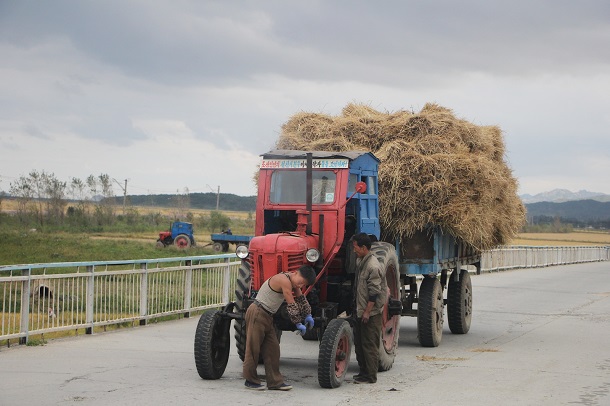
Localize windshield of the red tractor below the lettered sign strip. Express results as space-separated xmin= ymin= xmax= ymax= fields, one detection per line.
xmin=269 ymin=170 xmax=337 ymax=204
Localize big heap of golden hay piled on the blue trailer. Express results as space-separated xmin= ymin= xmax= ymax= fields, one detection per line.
xmin=276 ymin=104 xmax=525 ymax=250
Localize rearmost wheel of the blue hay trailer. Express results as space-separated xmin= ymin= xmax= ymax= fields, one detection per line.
xmin=447 ymin=269 xmax=472 ymax=334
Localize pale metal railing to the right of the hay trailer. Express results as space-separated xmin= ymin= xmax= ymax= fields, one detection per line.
xmin=481 ymin=245 xmax=610 ymax=272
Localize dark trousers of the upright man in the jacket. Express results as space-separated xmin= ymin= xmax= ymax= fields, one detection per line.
xmin=354 ymin=314 xmax=383 ymax=382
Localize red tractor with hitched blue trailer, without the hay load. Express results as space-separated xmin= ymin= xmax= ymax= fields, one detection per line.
xmin=194 ymin=150 xmax=480 ymax=388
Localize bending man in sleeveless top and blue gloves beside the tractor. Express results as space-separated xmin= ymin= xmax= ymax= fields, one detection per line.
xmin=243 ymin=265 xmax=316 ymax=391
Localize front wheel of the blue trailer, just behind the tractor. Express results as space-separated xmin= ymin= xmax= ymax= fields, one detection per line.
xmin=417 ymin=276 xmax=444 ymax=347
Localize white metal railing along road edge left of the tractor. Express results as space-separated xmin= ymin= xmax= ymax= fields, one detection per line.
xmin=0 ymin=254 xmax=240 ymax=344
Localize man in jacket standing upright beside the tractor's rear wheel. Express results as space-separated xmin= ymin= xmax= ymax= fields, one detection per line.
xmin=353 ymin=233 xmax=387 ymax=383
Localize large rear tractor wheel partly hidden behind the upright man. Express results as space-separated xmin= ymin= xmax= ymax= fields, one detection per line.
xmin=371 ymin=242 xmax=400 ymax=372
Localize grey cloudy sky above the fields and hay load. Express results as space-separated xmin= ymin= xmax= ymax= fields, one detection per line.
xmin=0 ymin=0 xmax=610 ymax=196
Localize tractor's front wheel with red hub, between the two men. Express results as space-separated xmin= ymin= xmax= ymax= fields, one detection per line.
xmin=318 ymin=319 xmax=354 ymax=388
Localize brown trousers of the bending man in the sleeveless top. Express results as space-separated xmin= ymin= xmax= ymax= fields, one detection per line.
xmin=243 ymin=304 xmax=284 ymax=387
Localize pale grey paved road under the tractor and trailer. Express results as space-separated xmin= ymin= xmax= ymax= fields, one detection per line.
xmin=0 ymin=262 xmax=610 ymax=406
